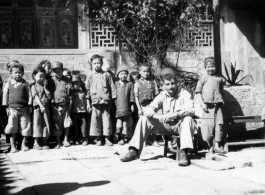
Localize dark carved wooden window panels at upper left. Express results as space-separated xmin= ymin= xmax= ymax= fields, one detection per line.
xmin=0 ymin=0 xmax=78 ymax=49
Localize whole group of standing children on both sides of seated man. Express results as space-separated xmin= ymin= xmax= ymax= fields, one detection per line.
xmin=2 ymin=54 xmax=226 ymax=153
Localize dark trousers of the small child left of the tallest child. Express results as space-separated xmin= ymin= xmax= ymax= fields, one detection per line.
xmin=72 ymin=113 xmax=88 ymax=140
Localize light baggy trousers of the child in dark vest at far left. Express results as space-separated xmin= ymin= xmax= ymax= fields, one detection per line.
xmin=5 ymin=107 xmax=31 ymax=137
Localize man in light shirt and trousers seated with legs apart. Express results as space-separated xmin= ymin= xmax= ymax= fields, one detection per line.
xmin=121 ymin=68 xmax=196 ymax=166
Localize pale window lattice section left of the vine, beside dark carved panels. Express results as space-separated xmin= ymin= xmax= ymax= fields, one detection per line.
xmin=91 ymin=23 xmax=117 ymax=48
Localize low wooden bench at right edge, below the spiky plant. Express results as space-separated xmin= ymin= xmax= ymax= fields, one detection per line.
xmin=224 ymin=116 xmax=265 ymax=152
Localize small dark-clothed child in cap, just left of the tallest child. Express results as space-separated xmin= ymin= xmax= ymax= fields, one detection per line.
xmin=71 ymin=75 xmax=88 ymax=146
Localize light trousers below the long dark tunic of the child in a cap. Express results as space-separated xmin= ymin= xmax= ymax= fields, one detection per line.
xmin=116 ymin=115 xmax=133 ymax=138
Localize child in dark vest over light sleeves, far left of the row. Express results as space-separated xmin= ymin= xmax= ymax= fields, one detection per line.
xmin=3 ymin=62 xmax=32 ymax=153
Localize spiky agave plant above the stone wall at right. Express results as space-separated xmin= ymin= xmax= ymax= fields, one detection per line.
xmin=223 ymin=62 xmax=253 ymax=85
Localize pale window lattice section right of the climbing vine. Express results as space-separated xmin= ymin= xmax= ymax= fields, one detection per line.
xmin=193 ymin=24 xmax=213 ymax=47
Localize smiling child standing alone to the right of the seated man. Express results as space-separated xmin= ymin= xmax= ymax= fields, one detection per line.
xmin=195 ymin=57 xmax=225 ymax=153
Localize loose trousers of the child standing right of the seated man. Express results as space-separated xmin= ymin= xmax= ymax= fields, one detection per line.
xmin=201 ymin=104 xmax=224 ymax=142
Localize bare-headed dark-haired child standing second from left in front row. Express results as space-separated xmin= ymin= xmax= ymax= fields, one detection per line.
xmin=31 ymin=67 xmax=51 ymax=150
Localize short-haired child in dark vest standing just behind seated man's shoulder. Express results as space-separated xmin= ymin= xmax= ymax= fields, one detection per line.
xmin=134 ymin=64 xmax=160 ymax=147
